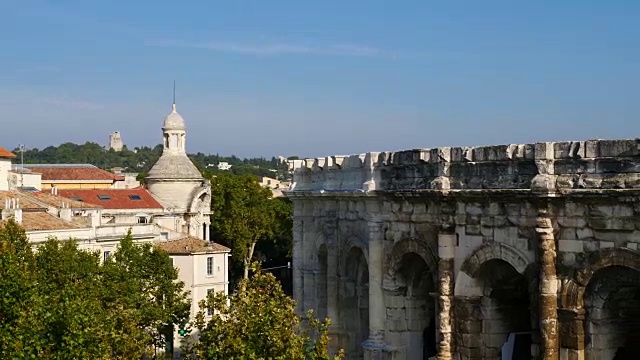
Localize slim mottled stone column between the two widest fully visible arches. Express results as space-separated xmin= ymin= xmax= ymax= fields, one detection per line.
xmin=438 ymin=228 xmax=456 ymax=360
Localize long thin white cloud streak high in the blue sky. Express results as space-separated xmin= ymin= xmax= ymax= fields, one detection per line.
xmin=146 ymin=40 xmax=382 ymax=56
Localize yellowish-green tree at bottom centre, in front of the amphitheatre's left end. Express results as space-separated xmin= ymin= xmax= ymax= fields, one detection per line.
xmin=187 ymin=265 xmax=344 ymax=360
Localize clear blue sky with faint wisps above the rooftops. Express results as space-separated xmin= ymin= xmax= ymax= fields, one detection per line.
xmin=0 ymin=0 xmax=640 ymax=157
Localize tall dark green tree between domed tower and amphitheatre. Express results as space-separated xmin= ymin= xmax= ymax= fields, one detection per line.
xmin=211 ymin=174 xmax=281 ymax=279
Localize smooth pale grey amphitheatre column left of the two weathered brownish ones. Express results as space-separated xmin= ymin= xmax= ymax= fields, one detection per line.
xmin=362 ymin=222 xmax=386 ymax=360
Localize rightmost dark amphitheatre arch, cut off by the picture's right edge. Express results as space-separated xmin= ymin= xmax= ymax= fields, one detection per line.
xmin=584 ymin=266 xmax=640 ymax=360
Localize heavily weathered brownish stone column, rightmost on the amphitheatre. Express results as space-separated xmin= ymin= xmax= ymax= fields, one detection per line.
xmin=536 ymin=207 xmax=559 ymax=360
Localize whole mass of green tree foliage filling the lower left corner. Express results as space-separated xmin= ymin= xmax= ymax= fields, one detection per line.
xmin=0 ymin=220 xmax=190 ymax=359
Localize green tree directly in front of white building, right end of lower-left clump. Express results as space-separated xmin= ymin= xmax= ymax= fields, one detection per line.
xmin=102 ymin=233 xmax=190 ymax=359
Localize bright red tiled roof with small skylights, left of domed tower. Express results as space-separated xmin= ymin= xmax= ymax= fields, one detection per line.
xmin=58 ymin=187 xmax=163 ymax=209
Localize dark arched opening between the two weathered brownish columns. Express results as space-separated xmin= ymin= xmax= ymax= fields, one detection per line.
xmin=474 ymin=259 xmax=531 ymax=360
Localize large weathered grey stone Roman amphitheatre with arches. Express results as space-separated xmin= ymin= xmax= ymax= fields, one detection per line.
xmin=286 ymin=140 xmax=640 ymax=360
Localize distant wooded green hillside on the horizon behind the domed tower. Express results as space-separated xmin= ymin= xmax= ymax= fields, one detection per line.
xmin=13 ymin=142 xmax=287 ymax=178
